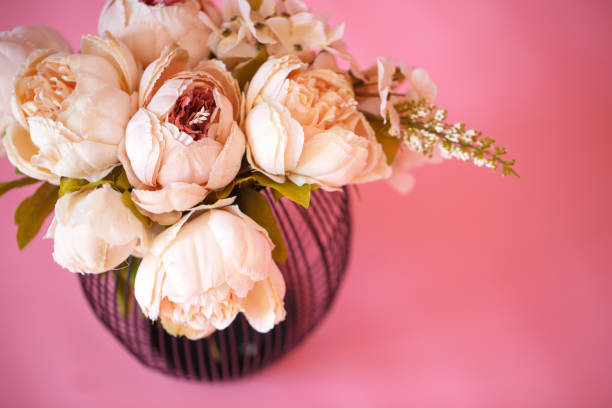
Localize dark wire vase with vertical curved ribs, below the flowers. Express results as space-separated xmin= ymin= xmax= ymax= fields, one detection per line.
xmin=79 ymin=189 xmax=351 ymax=381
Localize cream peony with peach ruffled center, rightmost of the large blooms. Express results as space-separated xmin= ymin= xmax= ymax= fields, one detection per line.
xmin=244 ymin=55 xmax=391 ymax=190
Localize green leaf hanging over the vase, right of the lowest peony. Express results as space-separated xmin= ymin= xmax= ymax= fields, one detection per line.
xmin=238 ymin=187 xmax=287 ymax=264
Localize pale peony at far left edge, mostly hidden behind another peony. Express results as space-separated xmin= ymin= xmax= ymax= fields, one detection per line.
xmin=0 ymin=26 xmax=72 ymax=155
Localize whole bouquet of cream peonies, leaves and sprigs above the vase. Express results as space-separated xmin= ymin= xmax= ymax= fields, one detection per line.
xmin=0 ymin=0 xmax=518 ymax=340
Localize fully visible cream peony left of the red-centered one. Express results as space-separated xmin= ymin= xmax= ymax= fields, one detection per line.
xmin=4 ymin=36 xmax=138 ymax=183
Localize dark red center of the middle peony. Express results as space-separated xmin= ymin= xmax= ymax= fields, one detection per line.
xmin=168 ymin=88 xmax=217 ymax=141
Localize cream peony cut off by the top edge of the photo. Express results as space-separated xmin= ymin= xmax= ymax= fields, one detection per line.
xmin=98 ymin=0 xmax=220 ymax=67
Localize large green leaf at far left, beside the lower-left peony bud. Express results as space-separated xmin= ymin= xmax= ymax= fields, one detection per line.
xmin=15 ymin=183 xmax=59 ymax=250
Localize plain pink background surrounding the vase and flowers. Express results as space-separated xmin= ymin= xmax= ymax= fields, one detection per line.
xmin=0 ymin=0 xmax=612 ymax=408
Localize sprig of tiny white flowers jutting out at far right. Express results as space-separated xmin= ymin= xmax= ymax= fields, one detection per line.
xmin=395 ymin=100 xmax=519 ymax=178
